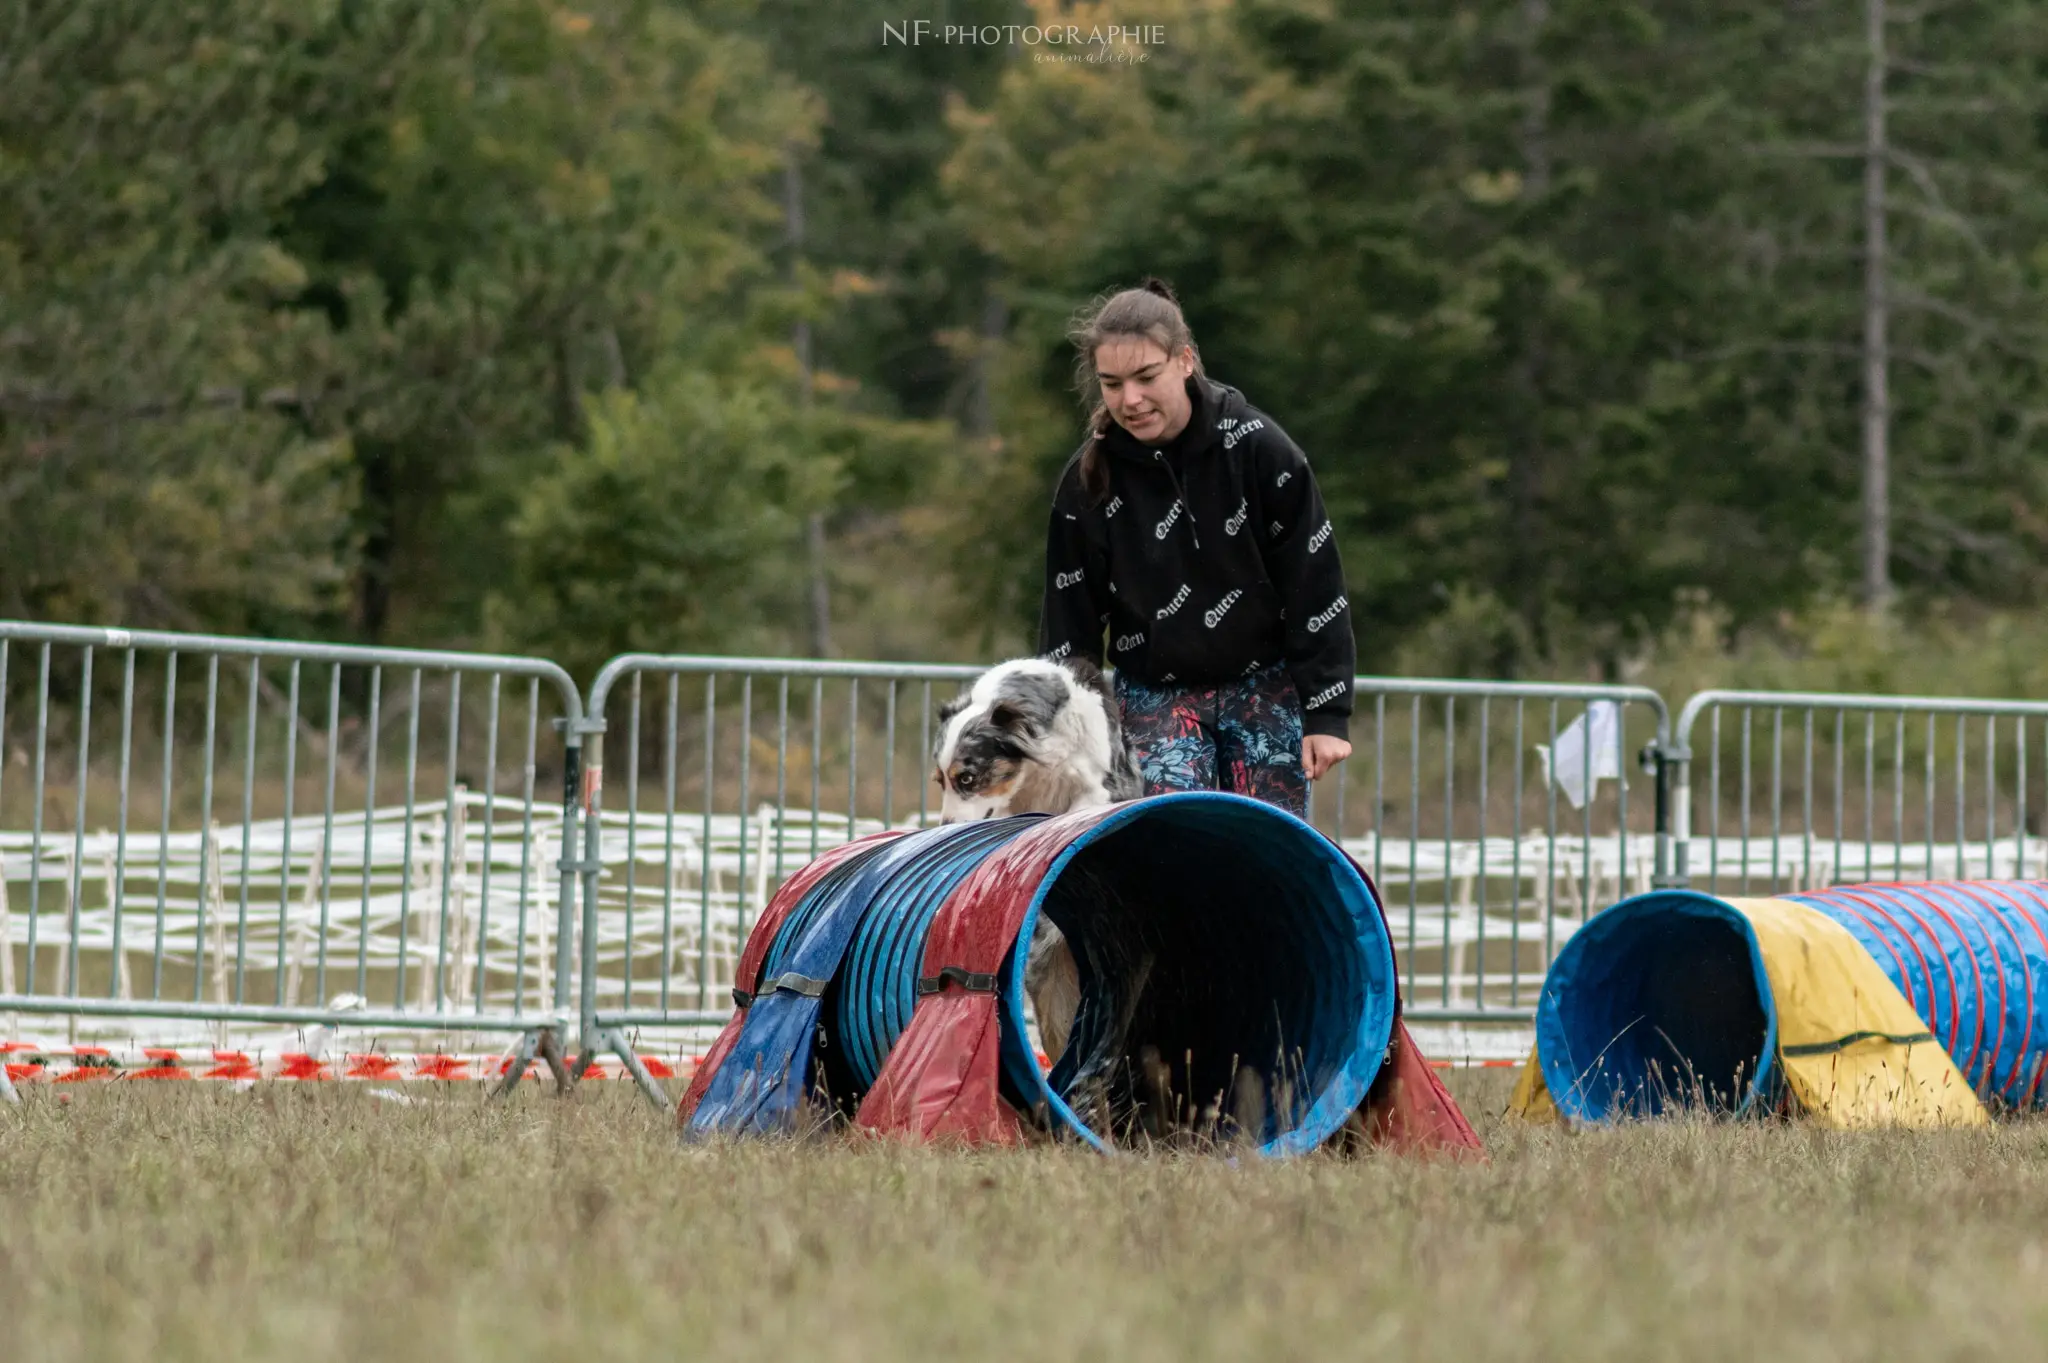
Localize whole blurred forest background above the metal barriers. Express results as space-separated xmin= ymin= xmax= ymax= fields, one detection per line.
xmin=12 ymin=0 xmax=2048 ymax=696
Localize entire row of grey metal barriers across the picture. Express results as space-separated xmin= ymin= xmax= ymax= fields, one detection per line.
xmin=16 ymin=622 xmax=2048 ymax=1093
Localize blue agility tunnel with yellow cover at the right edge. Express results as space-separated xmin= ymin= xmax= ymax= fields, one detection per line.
xmin=1511 ymin=880 xmax=2048 ymax=1128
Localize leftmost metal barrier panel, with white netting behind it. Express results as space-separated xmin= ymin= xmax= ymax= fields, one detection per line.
xmin=0 ymin=622 xmax=584 ymax=1068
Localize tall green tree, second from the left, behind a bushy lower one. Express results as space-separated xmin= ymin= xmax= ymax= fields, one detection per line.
xmin=281 ymin=0 xmax=811 ymax=639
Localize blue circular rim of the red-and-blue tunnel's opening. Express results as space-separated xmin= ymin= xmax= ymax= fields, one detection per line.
xmin=1001 ymin=790 xmax=1399 ymax=1158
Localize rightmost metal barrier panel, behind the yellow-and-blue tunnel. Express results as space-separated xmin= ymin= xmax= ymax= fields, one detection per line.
xmin=1671 ymin=692 xmax=2048 ymax=894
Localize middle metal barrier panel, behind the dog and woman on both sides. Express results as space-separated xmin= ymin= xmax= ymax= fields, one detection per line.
xmin=582 ymin=655 xmax=1669 ymax=1066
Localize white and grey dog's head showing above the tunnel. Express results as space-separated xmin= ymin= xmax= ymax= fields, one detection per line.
xmin=932 ymin=657 xmax=1128 ymax=823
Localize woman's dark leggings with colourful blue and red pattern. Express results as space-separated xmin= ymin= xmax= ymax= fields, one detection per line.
xmin=1116 ymin=665 xmax=1309 ymax=815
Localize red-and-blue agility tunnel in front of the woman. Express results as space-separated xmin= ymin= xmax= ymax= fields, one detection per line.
xmin=678 ymin=792 xmax=1477 ymax=1156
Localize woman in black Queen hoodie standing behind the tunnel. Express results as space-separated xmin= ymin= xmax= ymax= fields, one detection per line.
xmin=1038 ymin=280 xmax=1356 ymax=815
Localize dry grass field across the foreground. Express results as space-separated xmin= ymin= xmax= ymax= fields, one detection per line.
xmin=0 ymin=1072 xmax=2048 ymax=1363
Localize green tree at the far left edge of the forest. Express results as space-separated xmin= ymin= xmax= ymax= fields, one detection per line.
xmin=0 ymin=0 xmax=367 ymax=628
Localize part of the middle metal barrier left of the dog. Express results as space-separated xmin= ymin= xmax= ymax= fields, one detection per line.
xmin=580 ymin=655 xmax=983 ymax=1093
